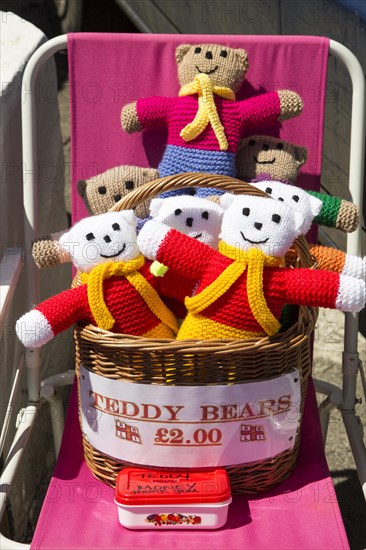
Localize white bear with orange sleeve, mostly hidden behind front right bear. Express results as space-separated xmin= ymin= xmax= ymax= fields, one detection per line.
xmin=252 ymin=180 xmax=366 ymax=280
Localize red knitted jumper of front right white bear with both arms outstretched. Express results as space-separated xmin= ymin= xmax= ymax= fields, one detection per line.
xmin=157 ymin=229 xmax=340 ymax=339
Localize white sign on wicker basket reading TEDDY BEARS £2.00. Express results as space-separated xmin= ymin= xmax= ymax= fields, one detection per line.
xmin=80 ymin=366 xmax=301 ymax=468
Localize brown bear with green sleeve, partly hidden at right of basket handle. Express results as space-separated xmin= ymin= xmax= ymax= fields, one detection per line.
xmin=236 ymin=135 xmax=359 ymax=233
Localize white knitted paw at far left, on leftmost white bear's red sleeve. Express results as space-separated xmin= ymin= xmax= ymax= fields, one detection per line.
xmin=15 ymin=309 xmax=54 ymax=348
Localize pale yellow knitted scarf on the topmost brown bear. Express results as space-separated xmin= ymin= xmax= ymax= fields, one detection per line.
xmin=179 ymin=73 xmax=235 ymax=151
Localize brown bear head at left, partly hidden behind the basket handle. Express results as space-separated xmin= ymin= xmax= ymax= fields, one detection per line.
xmin=77 ymin=165 xmax=159 ymax=219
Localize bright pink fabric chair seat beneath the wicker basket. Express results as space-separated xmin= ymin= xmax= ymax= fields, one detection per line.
xmin=31 ymin=385 xmax=349 ymax=550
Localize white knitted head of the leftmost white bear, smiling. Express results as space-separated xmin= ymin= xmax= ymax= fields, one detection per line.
xmin=60 ymin=210 xmax=138 ymax=272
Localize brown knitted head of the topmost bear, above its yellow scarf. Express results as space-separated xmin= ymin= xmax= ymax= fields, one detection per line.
xmin=175 ymin=44 xmax=248 ymax=92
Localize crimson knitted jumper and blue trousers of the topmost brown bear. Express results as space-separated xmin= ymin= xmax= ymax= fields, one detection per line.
xmin=136 ymin=92 xmax=281 ymax=179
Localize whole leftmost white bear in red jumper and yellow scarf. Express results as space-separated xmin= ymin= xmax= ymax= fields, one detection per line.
xmin=16 ymin=210 xmax=185 ymax=347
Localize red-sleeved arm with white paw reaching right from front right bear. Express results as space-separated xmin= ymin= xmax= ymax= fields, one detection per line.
xmin=277 ymin=268 xmax=366 ymax=312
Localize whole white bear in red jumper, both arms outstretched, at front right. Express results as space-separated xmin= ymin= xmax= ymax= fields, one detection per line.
xmin=137 ymin=194 xmax=366 ymax=340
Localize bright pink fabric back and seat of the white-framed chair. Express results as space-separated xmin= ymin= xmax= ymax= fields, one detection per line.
xmin=31 ymin=33 xmax=348 ymax=550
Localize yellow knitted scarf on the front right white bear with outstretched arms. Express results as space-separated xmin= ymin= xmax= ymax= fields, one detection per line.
xmin=185 ymin=245 xmax=282 ymax=336
